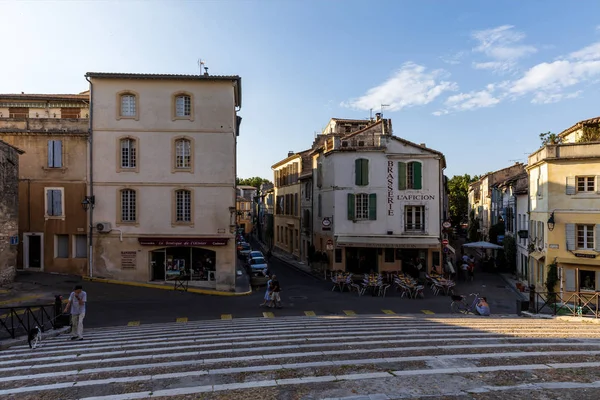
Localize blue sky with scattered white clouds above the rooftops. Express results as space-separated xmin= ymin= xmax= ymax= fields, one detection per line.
xmin=0 ymin=0 xmax=600 ymax=180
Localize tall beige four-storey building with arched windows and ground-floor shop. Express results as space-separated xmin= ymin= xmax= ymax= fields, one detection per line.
xmin=86 ymin=73 xmax=241 ymax=290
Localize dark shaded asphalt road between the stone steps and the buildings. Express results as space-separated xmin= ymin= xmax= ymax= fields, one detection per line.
xmin=71 ymin=244 xmax=518 ymax=327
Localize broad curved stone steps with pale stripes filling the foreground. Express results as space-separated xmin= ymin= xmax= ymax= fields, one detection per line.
xmin=0 ymin=313 xmax=600 ymax=400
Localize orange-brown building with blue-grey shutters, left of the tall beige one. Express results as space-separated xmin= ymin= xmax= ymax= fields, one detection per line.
xmin=0 ymin=92 xmax=89 ymax=275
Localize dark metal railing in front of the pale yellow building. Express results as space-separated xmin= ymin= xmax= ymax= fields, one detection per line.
xmin=529 ymin=292 xmax=600 ymax=318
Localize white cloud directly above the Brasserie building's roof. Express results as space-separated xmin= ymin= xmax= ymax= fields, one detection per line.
xmin=341 ymin=62 xmax=458 ymax=111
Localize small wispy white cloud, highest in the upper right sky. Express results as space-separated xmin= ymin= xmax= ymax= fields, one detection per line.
xmin=471 ymin=25 xmax=537 ymax=72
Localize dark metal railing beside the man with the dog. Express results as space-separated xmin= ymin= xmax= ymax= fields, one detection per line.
xmin=0 ymin=297 xmax=64 ymax=339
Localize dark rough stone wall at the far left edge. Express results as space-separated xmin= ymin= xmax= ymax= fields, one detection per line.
xmin=0 ymin=141 xmax=19 ymax=285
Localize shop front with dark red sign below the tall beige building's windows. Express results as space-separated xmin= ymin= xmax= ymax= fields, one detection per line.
xmin=138 ymin=238 xmax=228 ymax=287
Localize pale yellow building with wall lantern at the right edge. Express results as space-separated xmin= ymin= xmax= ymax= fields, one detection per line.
xmin=527 ymin=118 xmax=600 ymax=301
